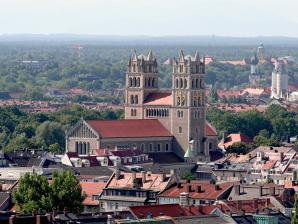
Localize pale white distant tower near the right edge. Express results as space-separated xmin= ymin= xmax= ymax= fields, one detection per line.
xmin=271 ymin=60 xmax=288 ymax=99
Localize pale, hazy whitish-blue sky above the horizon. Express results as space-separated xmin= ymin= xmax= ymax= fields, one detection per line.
xmin=0 ymin=0 xmax=298 ymax=37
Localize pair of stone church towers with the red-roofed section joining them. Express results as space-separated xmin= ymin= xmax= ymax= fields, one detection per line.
xmin=125 ymin=50 xmax=209 ymax=161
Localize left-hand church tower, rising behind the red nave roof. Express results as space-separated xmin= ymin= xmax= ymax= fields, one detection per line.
xmin=125 ymin=51 xmax=159 ymax=119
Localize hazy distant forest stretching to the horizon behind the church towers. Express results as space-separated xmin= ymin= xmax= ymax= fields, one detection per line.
xmin=0 ymin=42 xmax=298 ymax=102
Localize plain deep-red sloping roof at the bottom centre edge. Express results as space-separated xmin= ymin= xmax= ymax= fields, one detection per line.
xmin=129 ymin=204 xmax=187 ymax=219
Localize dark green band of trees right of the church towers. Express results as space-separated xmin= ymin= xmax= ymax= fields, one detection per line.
xmin=207 ymin=105 xmax=298 ymax=149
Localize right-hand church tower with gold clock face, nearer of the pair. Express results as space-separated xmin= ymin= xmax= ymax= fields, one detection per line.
xmin=171 ymin=50 xmax=209 ymax=161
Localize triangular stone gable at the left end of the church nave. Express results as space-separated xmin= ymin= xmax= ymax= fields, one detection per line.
xmin=66 ymin=119 xmax=98 ymax=138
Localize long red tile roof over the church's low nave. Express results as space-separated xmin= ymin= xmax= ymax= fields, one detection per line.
xmin=87 ymin=119 xmax=172 ymax=138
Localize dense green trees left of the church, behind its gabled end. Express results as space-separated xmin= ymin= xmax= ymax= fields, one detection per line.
xmin=0 ymin=105 xmax=123 ymax=152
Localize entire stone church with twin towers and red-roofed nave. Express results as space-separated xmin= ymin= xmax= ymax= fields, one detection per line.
xmin=66 ymin=50 xmax=217 ymax=162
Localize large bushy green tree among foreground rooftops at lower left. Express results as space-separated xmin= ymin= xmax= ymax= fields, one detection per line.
xmin=13 ymin=171 xmax=85 ymax=214
